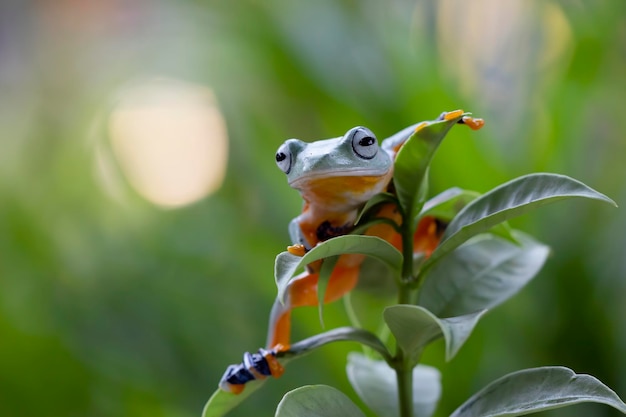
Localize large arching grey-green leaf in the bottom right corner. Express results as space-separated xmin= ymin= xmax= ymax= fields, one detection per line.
xmin=451 ymin=367 xmax=626 ymax=417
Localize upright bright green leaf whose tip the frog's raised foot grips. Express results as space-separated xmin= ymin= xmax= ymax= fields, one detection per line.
xmin=388 ymin=113 xmax=469 ymax=224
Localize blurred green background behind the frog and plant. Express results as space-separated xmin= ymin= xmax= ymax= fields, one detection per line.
xmin=0 ymin=0 xmax=626 ymax=417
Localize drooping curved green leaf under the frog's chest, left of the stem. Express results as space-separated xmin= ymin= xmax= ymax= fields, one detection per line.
xmin=274 ymin=235 xmax=402 ymax=300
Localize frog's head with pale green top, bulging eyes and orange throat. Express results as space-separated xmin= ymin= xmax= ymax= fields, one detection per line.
xmin=276 ymin=126 xmax=393 ymax=209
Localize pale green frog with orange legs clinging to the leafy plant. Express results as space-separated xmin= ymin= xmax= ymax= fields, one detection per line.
xmin=220 ymin=110 xmax=484 ymax=393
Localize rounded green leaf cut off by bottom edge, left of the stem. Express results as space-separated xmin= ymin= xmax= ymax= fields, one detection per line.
xmin=275 ymin=385 xmax=365 ymax=417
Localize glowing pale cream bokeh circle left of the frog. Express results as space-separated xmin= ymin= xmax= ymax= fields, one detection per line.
xmin=108 ymin=79 xmax=228 ymax=207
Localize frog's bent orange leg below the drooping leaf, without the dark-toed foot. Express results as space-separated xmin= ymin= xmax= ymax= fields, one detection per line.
xmin=266 ymin=255 xmax=362 ymax=351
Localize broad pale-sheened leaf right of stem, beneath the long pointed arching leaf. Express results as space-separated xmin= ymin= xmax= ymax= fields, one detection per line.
xmin=417 ymin=231 xmax=550 ymax=317
